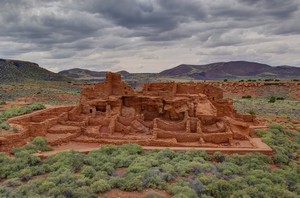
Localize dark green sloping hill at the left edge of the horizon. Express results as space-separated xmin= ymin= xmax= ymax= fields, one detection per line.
xmin=0 ymin=59 xmax=70 ymax=83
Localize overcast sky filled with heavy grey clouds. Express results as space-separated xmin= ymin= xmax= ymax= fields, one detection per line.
xmin=0 ymin=0 xmax=300 ymax=72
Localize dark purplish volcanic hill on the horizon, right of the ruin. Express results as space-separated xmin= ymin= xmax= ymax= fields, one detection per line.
xmin=159 ymin=61 xmax=300 ymax=79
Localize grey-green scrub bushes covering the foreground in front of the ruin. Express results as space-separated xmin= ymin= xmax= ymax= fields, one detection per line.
xmin=0 ymin=124 xmax=300 ymax=198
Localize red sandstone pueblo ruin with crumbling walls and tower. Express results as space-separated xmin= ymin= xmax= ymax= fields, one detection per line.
xmin=0 ymin=72 xmax=272 ymax=151
